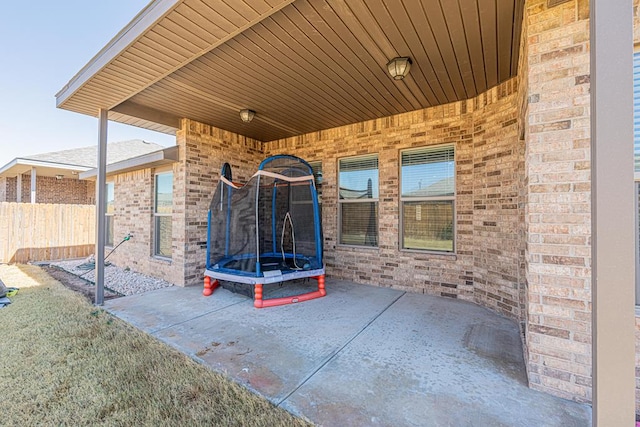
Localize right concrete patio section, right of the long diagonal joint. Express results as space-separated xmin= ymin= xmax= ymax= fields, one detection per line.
xmin=281 ymin=293 xmax=590 ymax=427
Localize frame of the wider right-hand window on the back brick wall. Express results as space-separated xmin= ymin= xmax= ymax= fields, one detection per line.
xmin=398 ymin=143 xmax=457 ymax=255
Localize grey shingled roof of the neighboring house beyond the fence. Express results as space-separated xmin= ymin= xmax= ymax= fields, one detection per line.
xmin=0 ymin=139 xmax=165 ymax=178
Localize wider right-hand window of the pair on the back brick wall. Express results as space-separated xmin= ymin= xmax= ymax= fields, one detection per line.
xmin=400 ymin=146 xmax=455 ymax=252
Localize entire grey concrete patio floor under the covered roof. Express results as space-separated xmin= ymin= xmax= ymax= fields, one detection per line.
xmin=105 ymin=280 xmax=591 ymax=427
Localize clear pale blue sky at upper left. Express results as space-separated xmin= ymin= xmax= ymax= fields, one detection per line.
xmin=0 ymin=0 xmax=175 ymax=168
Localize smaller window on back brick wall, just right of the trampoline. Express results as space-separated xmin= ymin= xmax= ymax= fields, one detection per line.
xmin=338 ymin=155 xmax=378 ymax=246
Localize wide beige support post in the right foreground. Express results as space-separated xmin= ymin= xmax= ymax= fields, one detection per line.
xmin=590 ymin=0 xmax=637 ymax=427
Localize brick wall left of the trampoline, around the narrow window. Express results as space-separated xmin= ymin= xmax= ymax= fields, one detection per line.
xmin=101 ymin=119 xmax=264 ymax=286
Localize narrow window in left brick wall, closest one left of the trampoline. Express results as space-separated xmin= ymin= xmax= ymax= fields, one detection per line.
xmin=153 ymin=172 xmax=173 ymax=258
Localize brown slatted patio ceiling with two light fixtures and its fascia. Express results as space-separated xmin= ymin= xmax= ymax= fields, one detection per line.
xmin=56 ymin=0 xmax=524 ymax=141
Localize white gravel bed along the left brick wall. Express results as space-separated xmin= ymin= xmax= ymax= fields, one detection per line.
xmin=48 ymin=256 xmax=174 ymax=295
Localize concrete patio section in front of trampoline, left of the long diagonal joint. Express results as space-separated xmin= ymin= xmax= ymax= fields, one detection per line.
xmin=155 ymin=282 xmax=402 ymax=404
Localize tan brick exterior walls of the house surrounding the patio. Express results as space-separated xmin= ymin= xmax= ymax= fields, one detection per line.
xmin=56 ymin=0 xmax=640 ymax=418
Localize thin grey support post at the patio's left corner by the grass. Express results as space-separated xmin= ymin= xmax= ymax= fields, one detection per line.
xmin=95 ymin=109 xmax=108 ymax=305
